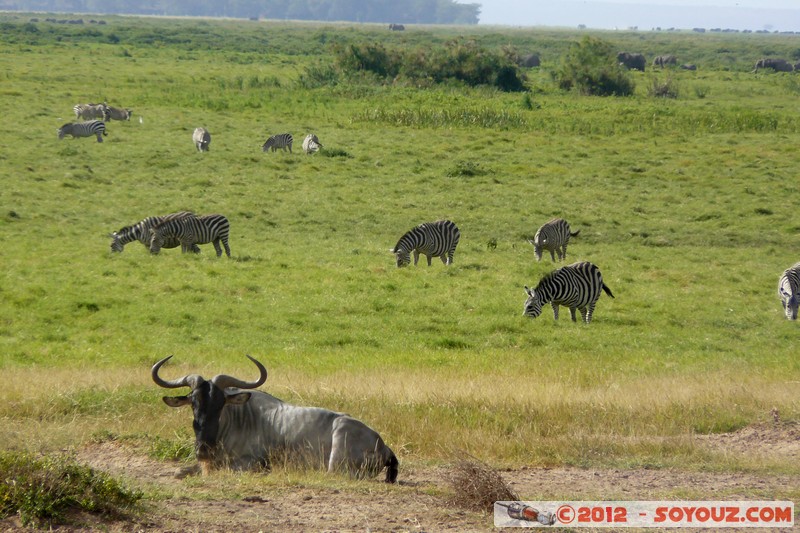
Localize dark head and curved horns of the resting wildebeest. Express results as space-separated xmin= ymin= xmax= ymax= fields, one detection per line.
xmin=151 ymin=355 xmax=267 ymax=464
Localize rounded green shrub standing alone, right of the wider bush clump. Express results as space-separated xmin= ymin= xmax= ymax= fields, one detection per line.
xmin=555 ymin=36 xmax=634 ymax=96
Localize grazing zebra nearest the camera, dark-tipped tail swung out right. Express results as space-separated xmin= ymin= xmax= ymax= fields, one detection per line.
xmin=522 ymin=261 xmax=614 ymax=324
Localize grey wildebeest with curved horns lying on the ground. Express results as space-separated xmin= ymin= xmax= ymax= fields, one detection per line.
xmin=151 ymin=355 xmax=399 ymax=483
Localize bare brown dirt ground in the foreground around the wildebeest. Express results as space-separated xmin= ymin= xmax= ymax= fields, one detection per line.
xmin=0 ymin=423 xmax=800 ymax=532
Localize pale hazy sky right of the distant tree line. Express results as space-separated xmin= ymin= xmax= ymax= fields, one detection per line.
xmin=476 ymin=0 xmax=800 ymax=31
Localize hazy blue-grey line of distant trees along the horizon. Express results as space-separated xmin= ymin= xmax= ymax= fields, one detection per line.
xmin=12 ymin=0 xmax=481 ymax=24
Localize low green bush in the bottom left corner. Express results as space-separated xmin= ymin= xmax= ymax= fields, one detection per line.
xmin=0 ymin=452 xmax=142 ymax=527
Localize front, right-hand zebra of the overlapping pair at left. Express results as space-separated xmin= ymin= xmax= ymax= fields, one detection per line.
xmin=150 ymin=215 xmax=231 ymax=257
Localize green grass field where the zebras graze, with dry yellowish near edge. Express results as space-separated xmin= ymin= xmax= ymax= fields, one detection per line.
xmin=0 ymin=15 xmax=800 ymax=490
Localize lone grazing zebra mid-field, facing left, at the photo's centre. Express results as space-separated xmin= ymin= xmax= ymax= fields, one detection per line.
xmin=391 ymin=220 xmax=461 ymax=268
